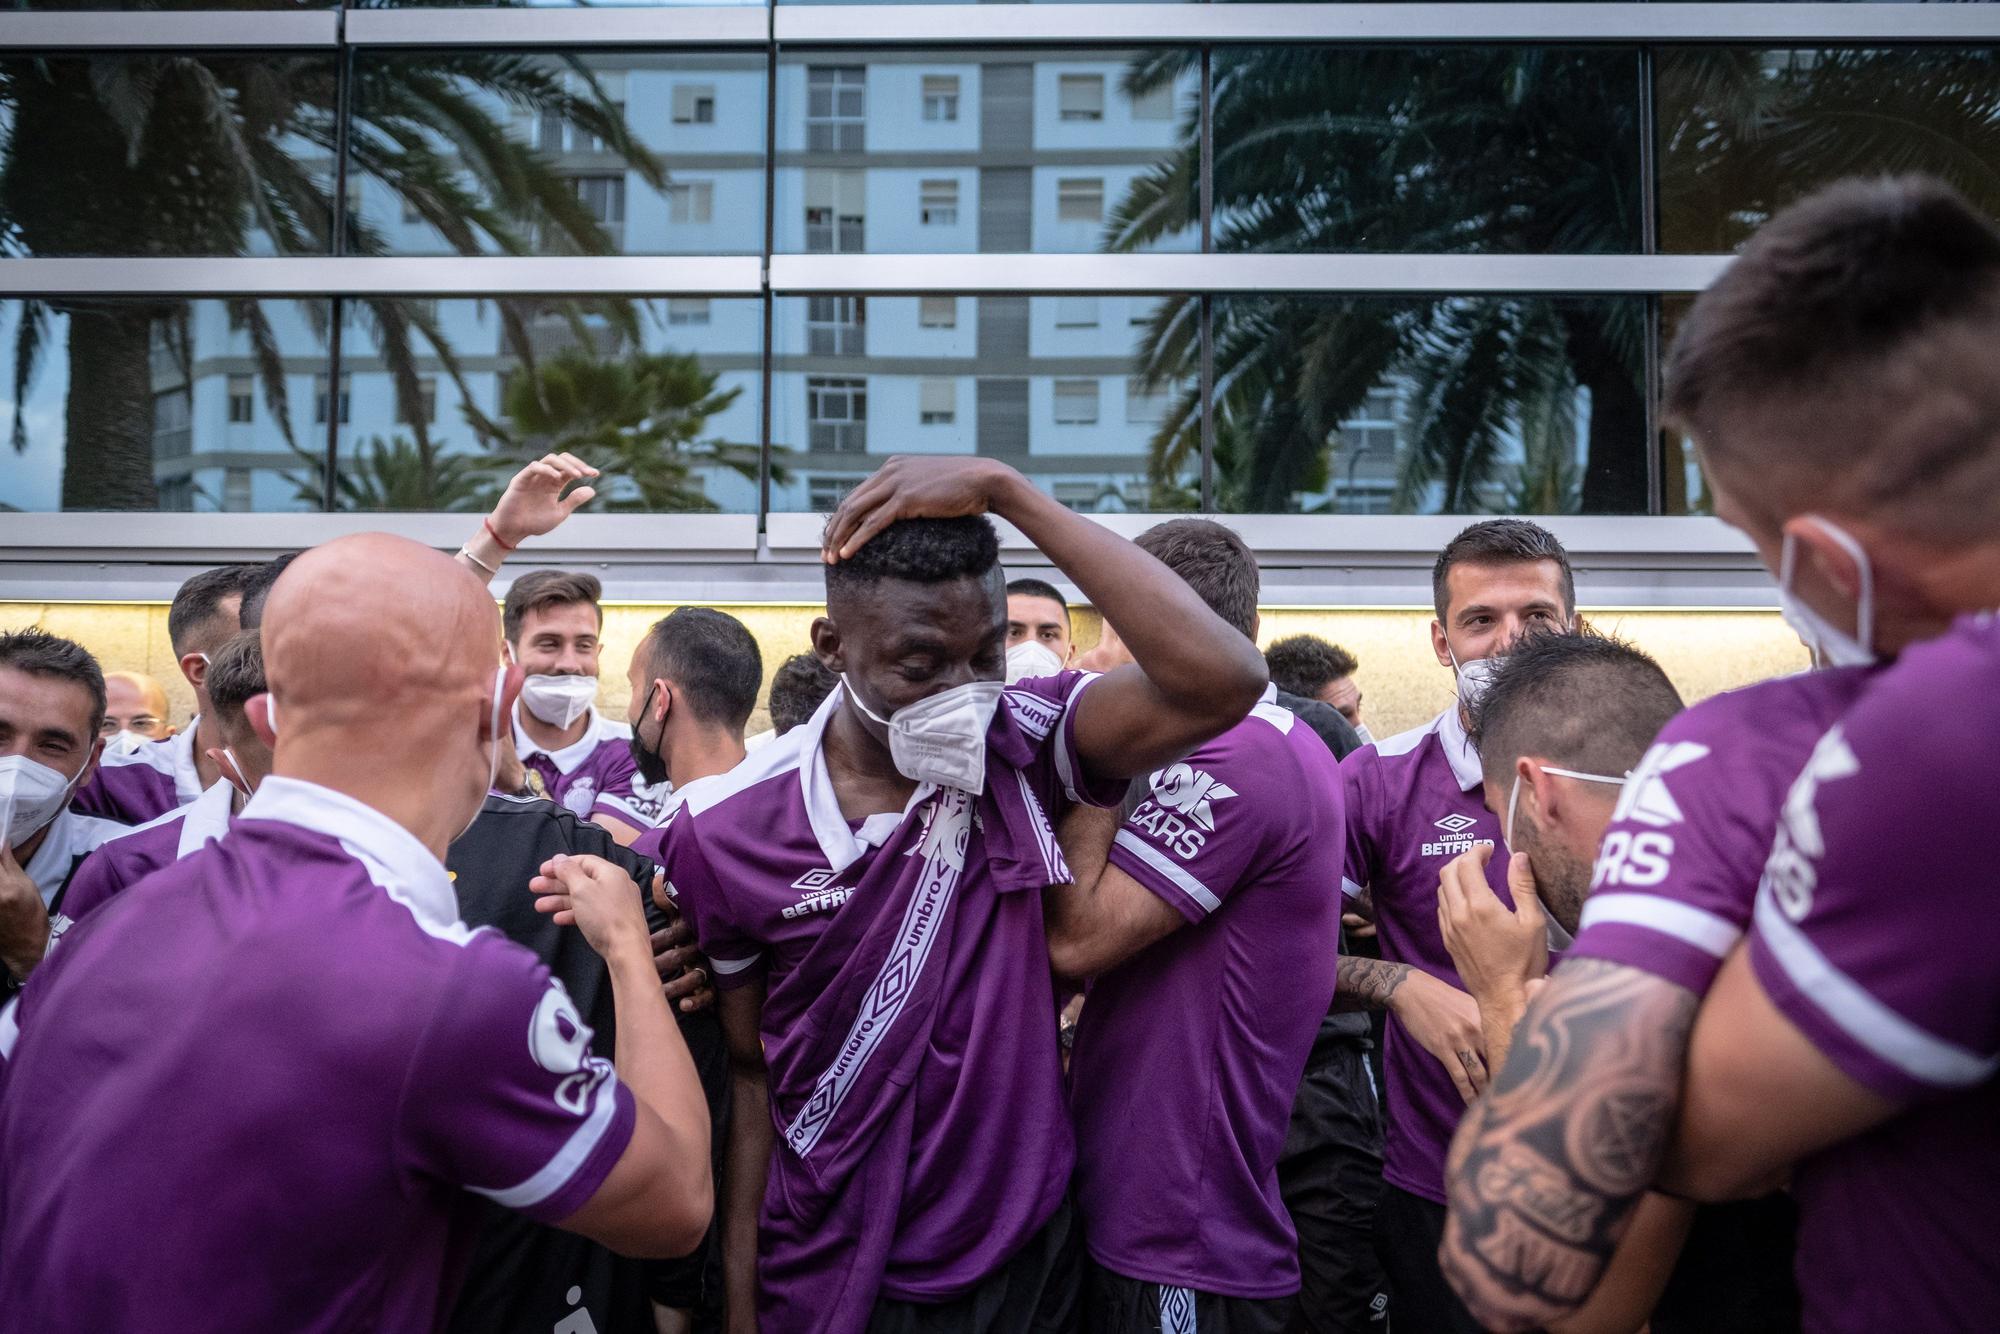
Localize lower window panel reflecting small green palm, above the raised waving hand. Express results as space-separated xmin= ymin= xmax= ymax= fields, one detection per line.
xmin=336 ymin=298 xmax=764 ymax=512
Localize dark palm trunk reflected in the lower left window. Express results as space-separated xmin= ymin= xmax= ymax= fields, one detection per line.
xmin=62 ymin=306 xmax=160 ymax=510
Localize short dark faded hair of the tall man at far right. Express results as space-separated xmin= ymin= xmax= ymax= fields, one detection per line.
xmin=1664 ymin=176 xmax=2000 ymax=536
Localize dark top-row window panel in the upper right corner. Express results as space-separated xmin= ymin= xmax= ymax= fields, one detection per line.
xmin=1654 ymin=46 xmax=2000 ymax=254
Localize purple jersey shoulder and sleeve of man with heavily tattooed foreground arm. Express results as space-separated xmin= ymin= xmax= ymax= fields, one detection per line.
xmin=1566 ymin=668 xmax=1874 ymax=996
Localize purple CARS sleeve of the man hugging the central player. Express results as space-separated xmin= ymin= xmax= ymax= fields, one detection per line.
xmin=1110 ymin=728 xmax=1296 ymax=922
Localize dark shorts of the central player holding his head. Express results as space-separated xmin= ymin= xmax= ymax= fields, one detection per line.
xmin=868 ymin=1200 xmax=1090 ymax=1334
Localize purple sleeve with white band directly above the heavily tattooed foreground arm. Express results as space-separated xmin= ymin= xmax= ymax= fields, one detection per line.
xmin=1568 ymin=724 xmax=1774 ymax=996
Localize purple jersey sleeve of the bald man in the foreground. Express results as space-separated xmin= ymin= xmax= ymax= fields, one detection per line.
xmin=400 ymin=932 xmax=636 ymax=1222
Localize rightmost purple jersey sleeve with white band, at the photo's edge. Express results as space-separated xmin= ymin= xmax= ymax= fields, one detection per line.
xmin=1750 ymin=688 xmax=2000 ymax=1104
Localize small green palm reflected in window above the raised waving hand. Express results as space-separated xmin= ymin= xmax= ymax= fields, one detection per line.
xmin=480 ymin=348 xmax=786 ymax=512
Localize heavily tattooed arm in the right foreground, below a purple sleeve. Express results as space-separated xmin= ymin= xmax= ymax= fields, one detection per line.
xmin=1438 ymin=958 xmax=1696 ymax=1330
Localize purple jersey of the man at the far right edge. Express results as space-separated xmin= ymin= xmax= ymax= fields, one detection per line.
xmin=1750 ymin=614 xmax=2000 ymax=1334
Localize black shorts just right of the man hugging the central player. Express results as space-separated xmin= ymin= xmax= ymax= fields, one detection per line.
xmin=1278 ymin=1042 xmax=1388 ymax=1334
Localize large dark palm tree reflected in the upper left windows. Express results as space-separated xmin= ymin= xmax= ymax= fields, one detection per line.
xmin=0 ymin=52 xmax=664 ymax=510
